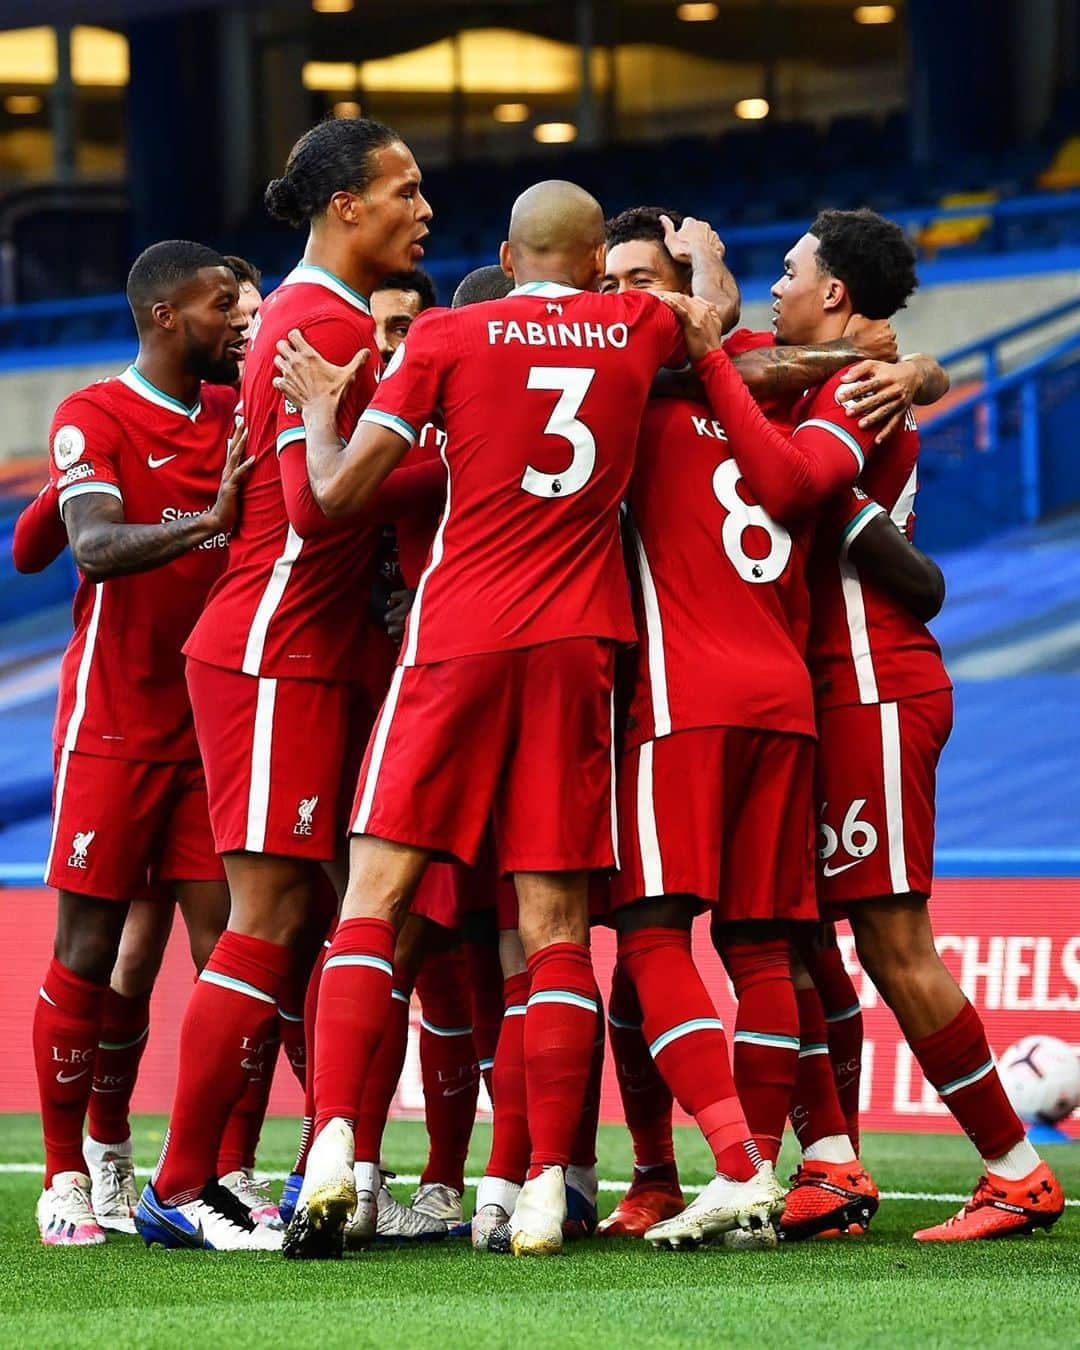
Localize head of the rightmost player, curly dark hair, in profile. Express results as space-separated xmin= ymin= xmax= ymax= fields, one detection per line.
xmin=772 ymin=208 xmax=918 ymax=344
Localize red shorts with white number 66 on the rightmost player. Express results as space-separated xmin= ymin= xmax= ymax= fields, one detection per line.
xmin=815 ymin=690 xmax=953 ymax=907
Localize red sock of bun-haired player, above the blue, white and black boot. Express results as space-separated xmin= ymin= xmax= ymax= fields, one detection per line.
xmin=154 ymin=929 xmax=292 ymax=1204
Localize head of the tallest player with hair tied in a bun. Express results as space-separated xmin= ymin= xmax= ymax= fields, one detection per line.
xmin=263 ymin=117 xmax=432 ymax=277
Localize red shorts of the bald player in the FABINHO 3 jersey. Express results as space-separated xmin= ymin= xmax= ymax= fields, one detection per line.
xmin=352 ymin=637 xmax=616 ymax=872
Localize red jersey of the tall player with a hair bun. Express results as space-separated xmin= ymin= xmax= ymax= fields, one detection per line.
xmin=185 ymin=263 xmax=379 ymax=680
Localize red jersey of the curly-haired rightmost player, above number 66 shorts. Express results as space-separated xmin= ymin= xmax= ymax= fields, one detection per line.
xmin=809 ymin=394 xmax=952 ymax=707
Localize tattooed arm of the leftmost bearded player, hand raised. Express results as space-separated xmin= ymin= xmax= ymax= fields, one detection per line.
xmin=63 ymin=427 xmax=254 ymax=582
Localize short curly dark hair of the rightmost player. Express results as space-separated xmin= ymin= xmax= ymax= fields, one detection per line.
xmin=810 ymin=207 xmax=919 ymax=319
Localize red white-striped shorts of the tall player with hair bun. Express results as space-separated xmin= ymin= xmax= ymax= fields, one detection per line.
xmin=188 ymin=657 xmax=371 ymax=861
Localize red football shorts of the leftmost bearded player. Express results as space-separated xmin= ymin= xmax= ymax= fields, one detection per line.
xmin=45 ymin=751 xmax=225 ymax=900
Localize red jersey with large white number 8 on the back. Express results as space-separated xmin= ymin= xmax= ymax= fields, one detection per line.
xmin=626 ymin=398 xmax=814 ymax=748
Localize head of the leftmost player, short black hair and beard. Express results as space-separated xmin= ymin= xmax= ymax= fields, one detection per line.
xmin=127 ymin=239 xmax=246 ymax=385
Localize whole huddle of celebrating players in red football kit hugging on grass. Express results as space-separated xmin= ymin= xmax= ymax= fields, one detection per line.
xmin=15 ymin=119 xmax=1065 ymax=1258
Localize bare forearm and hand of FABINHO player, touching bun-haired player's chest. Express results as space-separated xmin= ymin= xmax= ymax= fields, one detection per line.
xmin=274 ymin=328 xmax=409 ymax=520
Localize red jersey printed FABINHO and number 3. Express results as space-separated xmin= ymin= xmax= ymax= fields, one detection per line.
xmin=363 ymin=282 xmax=686 ymax=666
